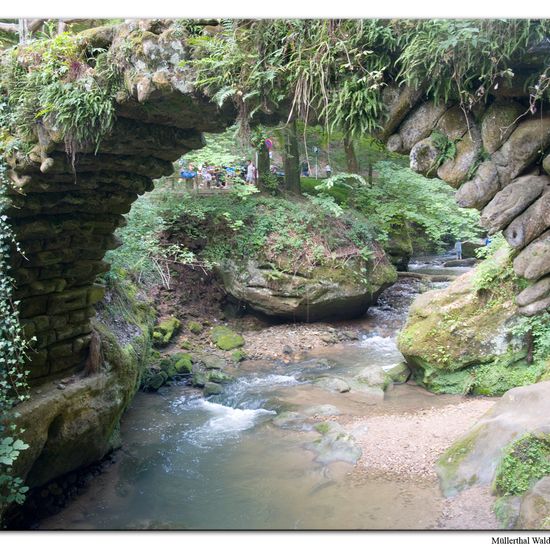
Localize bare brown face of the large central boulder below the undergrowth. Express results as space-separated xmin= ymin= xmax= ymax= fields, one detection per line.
xmin=217 ymin=256 xmax=397 ymax=321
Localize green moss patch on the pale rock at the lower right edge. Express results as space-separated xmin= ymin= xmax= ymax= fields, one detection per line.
xmin=494 ymin=433 xmax=550 ymax=496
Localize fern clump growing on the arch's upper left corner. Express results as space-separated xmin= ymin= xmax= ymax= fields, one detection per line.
xmin=0 ymin=33 xmax=121 ymax=161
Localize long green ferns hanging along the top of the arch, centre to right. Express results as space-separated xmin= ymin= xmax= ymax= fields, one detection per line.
xmin=185 ymin=19 xmax=549 ymax=136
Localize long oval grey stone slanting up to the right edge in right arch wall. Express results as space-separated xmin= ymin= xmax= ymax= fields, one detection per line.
xmin=480 ymin=176 xmax=550 ymax=235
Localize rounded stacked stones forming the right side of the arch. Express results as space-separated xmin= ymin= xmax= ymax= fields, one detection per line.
xmin=380 ymin=88 xmax=550 ymax=315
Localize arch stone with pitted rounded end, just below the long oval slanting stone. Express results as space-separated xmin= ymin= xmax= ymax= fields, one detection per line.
xmin=504 ymin=191 xmax=550 ymax=248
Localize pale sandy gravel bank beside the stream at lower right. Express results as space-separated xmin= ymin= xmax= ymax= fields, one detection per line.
xmin=343 ymin=398 xmax=500 ymax=530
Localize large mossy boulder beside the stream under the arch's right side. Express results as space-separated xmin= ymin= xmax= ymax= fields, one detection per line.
xmin=398 ymin=248 xmax=543 ymax=395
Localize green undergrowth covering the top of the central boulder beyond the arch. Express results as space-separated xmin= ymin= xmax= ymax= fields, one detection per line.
xmin=164 ymin=194 xmax=380 ymax=270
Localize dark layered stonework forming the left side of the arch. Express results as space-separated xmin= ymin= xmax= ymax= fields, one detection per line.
xmin=7 ymin=21 xmax=234 ymax=384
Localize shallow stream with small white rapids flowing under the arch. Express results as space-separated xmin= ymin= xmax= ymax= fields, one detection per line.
xmin=39 ymin=256 xmax=484 ymax=529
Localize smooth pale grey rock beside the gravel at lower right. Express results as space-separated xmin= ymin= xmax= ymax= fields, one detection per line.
xmin=437 ymin=382 xmax=550 ymax=496
